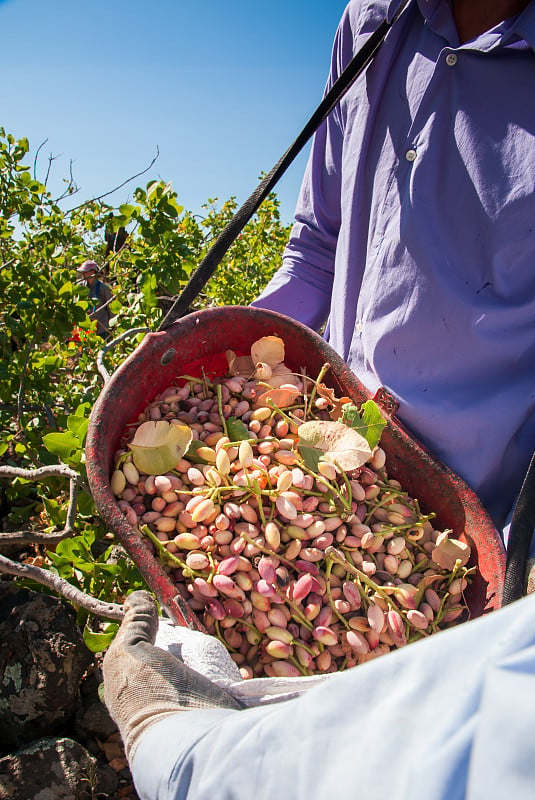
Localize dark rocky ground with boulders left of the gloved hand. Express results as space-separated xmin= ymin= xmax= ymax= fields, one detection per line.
xmin=0 ymin=580 xmax=138 ymax=800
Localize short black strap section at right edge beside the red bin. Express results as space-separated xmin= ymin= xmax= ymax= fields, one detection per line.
xmin=502 ymin=453 xmax=535 ymax=606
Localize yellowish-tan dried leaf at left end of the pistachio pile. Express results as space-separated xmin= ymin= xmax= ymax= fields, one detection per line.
xmin=128 ymin=420 xmax=193 ymax=475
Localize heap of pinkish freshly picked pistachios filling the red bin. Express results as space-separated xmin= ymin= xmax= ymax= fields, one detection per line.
xmin=111 ymin=375 xmax=474 ymax=678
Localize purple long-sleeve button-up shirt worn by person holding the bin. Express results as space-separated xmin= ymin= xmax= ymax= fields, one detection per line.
xmin=254 ymin=0 xmax=535 ymax=527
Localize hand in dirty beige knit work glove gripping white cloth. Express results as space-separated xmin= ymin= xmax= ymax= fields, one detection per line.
xmin=103 ymin=591 xmax=242 ymax=761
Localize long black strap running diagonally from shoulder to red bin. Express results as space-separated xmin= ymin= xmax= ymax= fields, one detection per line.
xmin=158 ymin=0 xmax=410 ymax=331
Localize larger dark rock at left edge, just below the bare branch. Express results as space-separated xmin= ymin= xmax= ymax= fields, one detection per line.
xmin=0 ymin=583 xmax=93 ymax=754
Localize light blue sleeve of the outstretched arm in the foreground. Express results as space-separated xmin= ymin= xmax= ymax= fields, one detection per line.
xmin=132 ymin=595 xmax=535 ymax=800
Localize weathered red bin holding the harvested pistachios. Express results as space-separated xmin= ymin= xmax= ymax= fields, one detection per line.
xmin=86 ymin=306 xmax=505 ymax=630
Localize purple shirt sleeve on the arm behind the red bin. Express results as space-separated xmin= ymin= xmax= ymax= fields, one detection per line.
xmin=252 ymin=1 xmax=353 ymax=330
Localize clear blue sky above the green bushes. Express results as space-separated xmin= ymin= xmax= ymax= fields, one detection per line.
xmin=0 ymin=0 xmax=346 ymax=222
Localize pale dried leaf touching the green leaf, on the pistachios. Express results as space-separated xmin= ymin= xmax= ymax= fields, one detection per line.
xmin=299 ymin=420 xmax=372 ymax=472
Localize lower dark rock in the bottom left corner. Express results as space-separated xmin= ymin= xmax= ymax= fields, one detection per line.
xmin=0 ymin=737 xmax=118 ymax=800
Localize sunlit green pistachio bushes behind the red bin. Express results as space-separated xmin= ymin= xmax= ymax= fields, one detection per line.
xmin=0 ymin=128 xmax=289 ymax=576
